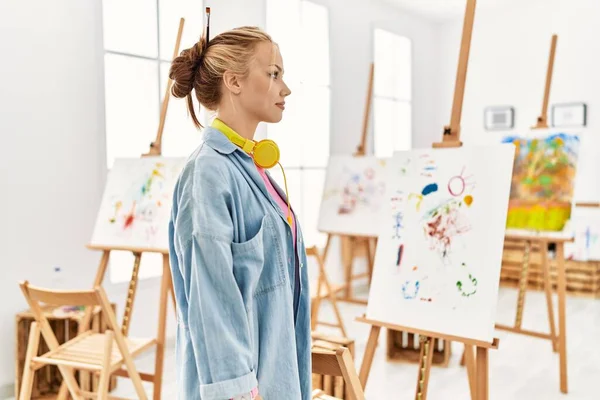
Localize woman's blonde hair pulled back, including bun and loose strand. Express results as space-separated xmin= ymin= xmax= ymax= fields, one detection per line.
xmin=169 ymin=26 xmax=273 ymax=128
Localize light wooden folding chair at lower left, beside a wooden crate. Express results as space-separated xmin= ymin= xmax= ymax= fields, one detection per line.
xmin=19 ymin=281 xmax=156 ymax=400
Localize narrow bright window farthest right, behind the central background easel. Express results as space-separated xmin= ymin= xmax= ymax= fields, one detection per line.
xmin=373 ymin=29 xmax=412 ymax=157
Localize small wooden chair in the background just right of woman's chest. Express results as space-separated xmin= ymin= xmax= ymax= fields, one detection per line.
xmin=306 ymin=246 xmax=347 ymax=337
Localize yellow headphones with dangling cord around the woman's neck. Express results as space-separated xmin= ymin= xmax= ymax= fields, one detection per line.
xmin=212 ymin=118 xmax=292 ymax=226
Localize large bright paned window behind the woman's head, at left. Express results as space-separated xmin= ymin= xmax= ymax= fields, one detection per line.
xmin=102 ymin=0 xmax=204 ymax=282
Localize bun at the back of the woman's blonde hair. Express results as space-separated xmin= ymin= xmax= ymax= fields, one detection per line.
xmin=169 ymin=37 xmax=206 ymax=98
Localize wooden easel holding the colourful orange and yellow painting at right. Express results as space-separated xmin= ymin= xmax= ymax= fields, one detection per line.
xmin=496 ymin=35 xmax=573 ymax=393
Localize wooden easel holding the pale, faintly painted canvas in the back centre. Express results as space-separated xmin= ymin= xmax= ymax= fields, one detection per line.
xmin=323 ymin=63 xmax=377 ymax=305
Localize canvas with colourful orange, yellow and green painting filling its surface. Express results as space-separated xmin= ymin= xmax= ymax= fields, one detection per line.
xmin=503 ymin=132 xmax=580 ymax=231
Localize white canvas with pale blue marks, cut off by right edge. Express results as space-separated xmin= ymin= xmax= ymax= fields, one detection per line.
xmin=565 ymin=207 xmax=600 ymax=261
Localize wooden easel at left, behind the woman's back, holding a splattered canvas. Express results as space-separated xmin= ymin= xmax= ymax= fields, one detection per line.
xmin=78 ymin=18 xmax=185 ymax=400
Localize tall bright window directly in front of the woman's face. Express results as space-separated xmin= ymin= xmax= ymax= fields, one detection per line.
xmin=267 ymin=0 xmax=331 ymax=245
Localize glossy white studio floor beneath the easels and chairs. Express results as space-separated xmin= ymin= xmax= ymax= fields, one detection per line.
xmin=5 ymin=289 xmax=600 ymax=400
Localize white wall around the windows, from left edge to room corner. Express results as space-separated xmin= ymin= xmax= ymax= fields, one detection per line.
xmin=0 ymin=0 xmax=438 ymax=398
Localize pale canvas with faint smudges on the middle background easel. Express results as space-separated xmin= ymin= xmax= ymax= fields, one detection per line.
xmin=318 ymin=155 xmax=386 ymax=237
